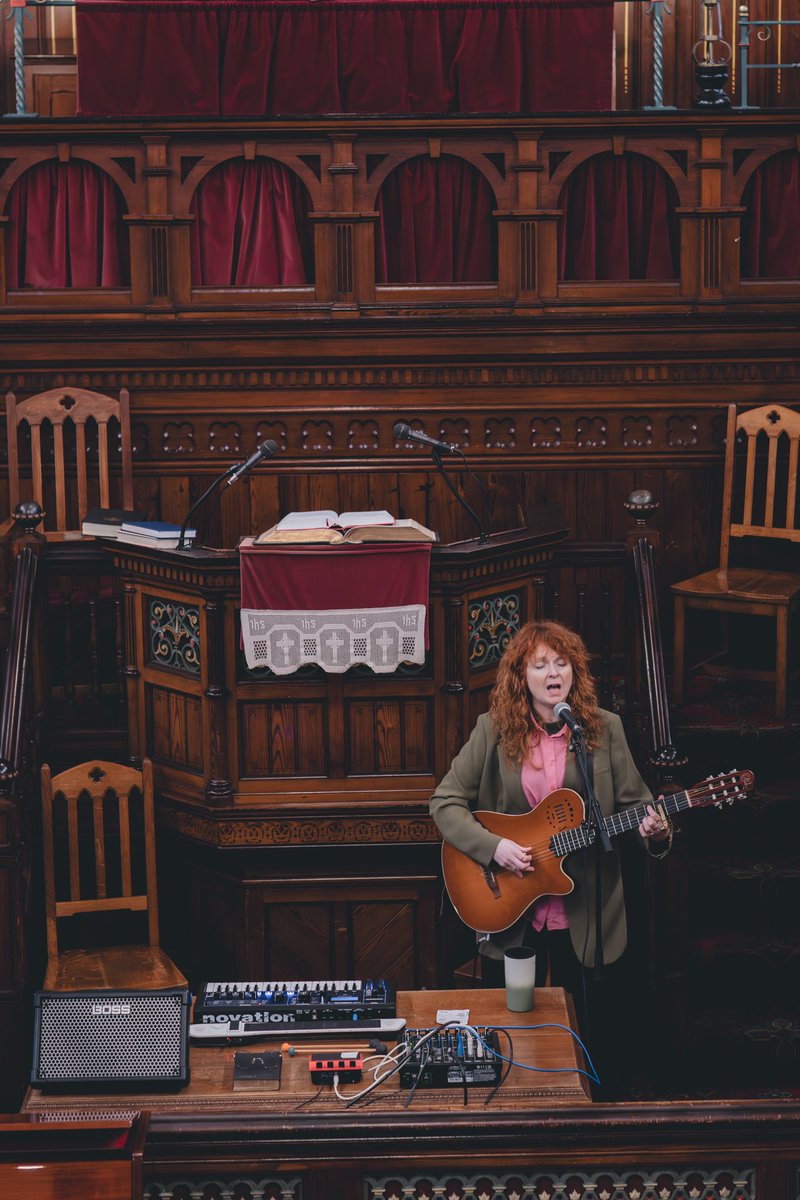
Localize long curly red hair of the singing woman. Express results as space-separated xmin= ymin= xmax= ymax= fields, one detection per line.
xmin=489 ymin=620 xmax=601 ymax=762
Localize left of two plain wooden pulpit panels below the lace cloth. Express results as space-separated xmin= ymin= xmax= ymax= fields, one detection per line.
xmin=239 ymin=698 xmax=327 ymax=779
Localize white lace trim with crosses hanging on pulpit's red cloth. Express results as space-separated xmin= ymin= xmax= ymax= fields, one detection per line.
xmin=241 ymin=604 xmax=425 ymax=674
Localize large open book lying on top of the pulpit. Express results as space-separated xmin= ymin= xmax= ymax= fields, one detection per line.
xmin=253 ymin=509 xmax=439 ymax=546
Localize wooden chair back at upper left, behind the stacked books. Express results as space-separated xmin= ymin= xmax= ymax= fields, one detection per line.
xmin=6 ymin=388 xmax=133 ymax=535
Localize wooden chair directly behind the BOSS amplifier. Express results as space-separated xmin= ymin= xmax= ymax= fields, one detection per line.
xmin=42 ymin=760 xmax=186 ymax=991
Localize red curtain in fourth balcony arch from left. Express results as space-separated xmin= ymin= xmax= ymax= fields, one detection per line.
xmin=559 ymin=154 xmax=680 ymax=281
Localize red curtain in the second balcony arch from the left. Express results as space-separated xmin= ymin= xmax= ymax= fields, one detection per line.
xmin=191 ymin=157 xmax=313 ymax=287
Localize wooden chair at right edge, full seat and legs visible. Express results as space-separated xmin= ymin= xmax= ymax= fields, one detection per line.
xmin=672 ymin=404 xmax=800 ymax=718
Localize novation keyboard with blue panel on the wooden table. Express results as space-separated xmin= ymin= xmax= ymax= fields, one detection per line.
xmin=194 ymin=979 xmax=397 ymax=1028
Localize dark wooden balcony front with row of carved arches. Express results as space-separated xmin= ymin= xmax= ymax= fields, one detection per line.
xmin=0 ymin=112 xmax=800 ymax=328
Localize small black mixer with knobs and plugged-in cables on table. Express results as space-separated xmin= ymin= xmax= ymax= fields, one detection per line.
xmin=399 ymin=1026 xmax=504 ymax=1088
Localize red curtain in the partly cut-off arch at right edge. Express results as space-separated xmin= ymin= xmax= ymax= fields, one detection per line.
xmin=741 ymin=150 xmax=800 ymax=280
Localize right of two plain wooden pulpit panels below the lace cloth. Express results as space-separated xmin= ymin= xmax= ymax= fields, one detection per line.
xmin=344 ymin=697 xmax=433 ymax=775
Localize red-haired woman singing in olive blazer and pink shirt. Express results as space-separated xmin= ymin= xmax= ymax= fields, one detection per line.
xmin=431 ymin=620 xmax=672 ymax=993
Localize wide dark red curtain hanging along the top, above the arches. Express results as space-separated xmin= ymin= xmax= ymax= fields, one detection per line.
xmin=77 ymin=0 xmax=613 ymax=116
